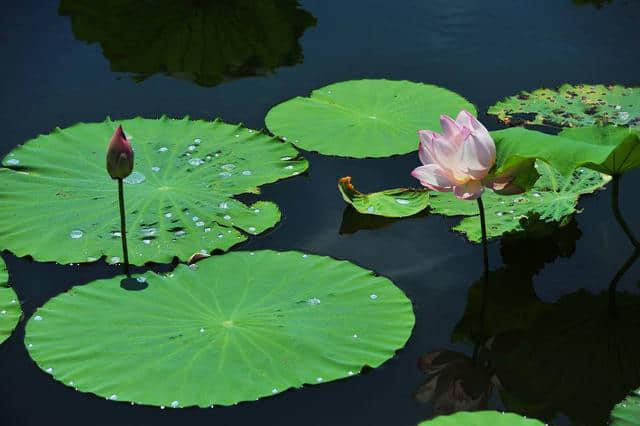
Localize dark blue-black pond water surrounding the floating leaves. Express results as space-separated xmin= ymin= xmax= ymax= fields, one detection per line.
xmin=0 ymin=0 xmax=640 ymax=425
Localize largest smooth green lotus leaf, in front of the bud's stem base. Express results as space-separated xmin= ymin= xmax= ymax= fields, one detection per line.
xmin=25 ymin=251 xmax=414 ymax=407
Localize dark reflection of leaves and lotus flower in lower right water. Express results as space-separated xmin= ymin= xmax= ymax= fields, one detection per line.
xmin=414 ymin=222 xmax=640 ymax=425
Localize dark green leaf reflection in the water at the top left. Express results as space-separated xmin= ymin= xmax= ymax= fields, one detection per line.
xmin=58 ymin=0 xmax=316 ymax=86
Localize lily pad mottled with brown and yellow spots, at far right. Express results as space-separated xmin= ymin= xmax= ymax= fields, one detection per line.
xmin=488 ymin=84 xmax=640 ymax=127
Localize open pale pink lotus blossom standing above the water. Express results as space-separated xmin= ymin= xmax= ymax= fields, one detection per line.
xmin=411 ymin=111 xmax=498 ymax=200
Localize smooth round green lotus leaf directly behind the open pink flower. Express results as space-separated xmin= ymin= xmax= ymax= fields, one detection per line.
xmin=265 ymin=80 xmax=476 ymax=158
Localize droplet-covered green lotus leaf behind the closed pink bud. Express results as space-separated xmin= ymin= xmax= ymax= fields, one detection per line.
xmin=0 ymin=117 xmax=308 ymax=265
